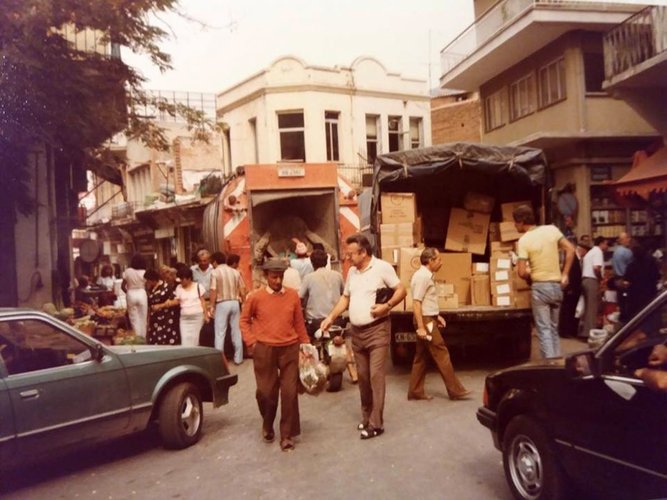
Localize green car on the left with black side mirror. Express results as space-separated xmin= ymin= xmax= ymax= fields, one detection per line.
xmin=0 ymin=309 xmax=237 ymax=466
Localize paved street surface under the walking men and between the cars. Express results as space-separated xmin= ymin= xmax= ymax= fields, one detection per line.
xmin=0 ymin=339 xmax=584 ymax=500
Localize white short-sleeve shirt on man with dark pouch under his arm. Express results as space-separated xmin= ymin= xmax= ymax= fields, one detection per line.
xmin=343 ymin=257 xmax=401 ymax=326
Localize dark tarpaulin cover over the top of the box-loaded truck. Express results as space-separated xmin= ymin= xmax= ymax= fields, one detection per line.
xmin=372 ymin=142 xmax=548 ymax=231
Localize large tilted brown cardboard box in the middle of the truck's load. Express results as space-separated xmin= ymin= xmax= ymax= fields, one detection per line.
xmin=445 ymin=208 xmax=491 ymax=255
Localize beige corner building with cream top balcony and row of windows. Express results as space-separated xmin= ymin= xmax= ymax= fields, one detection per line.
xmin=440 ymin=0 xmax=660 ymax=240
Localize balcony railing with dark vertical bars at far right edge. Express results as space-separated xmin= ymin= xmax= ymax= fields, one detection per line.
xmin=603 ymin=5 xmax=667 ymax=80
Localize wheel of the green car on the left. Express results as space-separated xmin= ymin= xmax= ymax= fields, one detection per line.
xmin=158 ymin=382 xmax=204 ymax=449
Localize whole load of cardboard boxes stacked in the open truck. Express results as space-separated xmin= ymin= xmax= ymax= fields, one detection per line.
xmin=380 ymin=193 xmax=530 ymax=311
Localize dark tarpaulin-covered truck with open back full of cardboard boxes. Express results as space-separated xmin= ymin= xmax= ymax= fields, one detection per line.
xmin=370 ymin=143 xmax=547 ymax=363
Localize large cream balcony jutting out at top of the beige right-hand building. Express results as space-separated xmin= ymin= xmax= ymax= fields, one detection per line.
xmin=440 ymin=0 xmax=640 ymax=90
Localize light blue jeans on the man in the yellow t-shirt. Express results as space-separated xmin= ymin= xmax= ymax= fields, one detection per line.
xmin=530 ymin=281 xmax=563 ymax=358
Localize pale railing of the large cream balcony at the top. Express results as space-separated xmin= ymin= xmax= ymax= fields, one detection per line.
xmin=440 ymin=0 xmax=620 ymax=75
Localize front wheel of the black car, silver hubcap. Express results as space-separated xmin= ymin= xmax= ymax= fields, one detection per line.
xmin=503 ymin=416 xmax=566 ymax=500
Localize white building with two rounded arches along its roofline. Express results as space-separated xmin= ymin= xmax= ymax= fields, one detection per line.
xmin=217 ymin=56 xmax=431 ymax=186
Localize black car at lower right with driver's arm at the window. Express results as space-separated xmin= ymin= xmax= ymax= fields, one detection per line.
xmin=477 ymin=292 xmax=667 ymax=499
